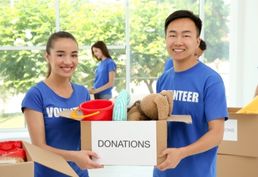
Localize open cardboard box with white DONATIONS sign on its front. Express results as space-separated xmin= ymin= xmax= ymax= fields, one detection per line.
xmin=81 ymin=116 xmax=191 ymax=166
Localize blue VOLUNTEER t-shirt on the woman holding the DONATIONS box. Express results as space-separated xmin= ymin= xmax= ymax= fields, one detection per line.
xmin=22 ymin=81 xmax=90 ymax=177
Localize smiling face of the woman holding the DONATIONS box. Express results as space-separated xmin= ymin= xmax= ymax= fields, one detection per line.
xmin=46 ymin=38 xmax=78 ymax=78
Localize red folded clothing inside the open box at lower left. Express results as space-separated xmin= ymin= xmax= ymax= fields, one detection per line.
xmin=0 ymin=141 xmax=26 ymax=163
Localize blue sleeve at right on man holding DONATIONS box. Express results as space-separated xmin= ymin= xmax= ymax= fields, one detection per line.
xmin=204 ymin=75 xmax=227 ymax=121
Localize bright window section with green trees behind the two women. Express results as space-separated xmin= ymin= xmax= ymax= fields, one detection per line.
xmin=0 ymin=0 xmax=126 ymax=129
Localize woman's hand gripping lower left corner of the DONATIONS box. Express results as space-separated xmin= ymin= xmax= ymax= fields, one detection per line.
xmin=72 ymin=150 xmax=103 ymax=169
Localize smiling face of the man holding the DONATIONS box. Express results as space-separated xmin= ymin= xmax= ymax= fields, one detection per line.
xmin=166 ymin=18 xmax=200 ymax=63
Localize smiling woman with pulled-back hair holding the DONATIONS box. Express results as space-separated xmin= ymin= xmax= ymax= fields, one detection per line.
xmin=22 ymin=31 xmax=102 ymax=177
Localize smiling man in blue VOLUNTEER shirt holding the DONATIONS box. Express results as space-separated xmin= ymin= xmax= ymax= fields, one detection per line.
xmin=153 ymin=10 xmax=227 ymax=177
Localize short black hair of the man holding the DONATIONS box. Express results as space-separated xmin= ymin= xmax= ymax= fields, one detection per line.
xmin=165 ymin=10 xmax=202 ymax=36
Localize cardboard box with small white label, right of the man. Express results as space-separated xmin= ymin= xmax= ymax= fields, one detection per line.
xmin=217 ymin=108 xmax=258 ymax=177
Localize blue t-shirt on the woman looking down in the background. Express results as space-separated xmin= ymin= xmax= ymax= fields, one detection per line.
xmin=93 ymin=58 xmax=116 ymax=95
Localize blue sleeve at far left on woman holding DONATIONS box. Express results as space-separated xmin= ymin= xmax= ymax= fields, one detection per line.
xmin=22 ymin=87 xmax=43 ymax=112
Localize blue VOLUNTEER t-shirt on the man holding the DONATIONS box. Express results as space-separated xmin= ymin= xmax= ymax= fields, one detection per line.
xmin=153 ymin=62 xmax=227 ymax=177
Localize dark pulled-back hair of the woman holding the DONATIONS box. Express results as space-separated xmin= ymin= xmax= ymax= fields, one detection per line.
xmin=46 ymin=31 xmax=78 ymax=77
